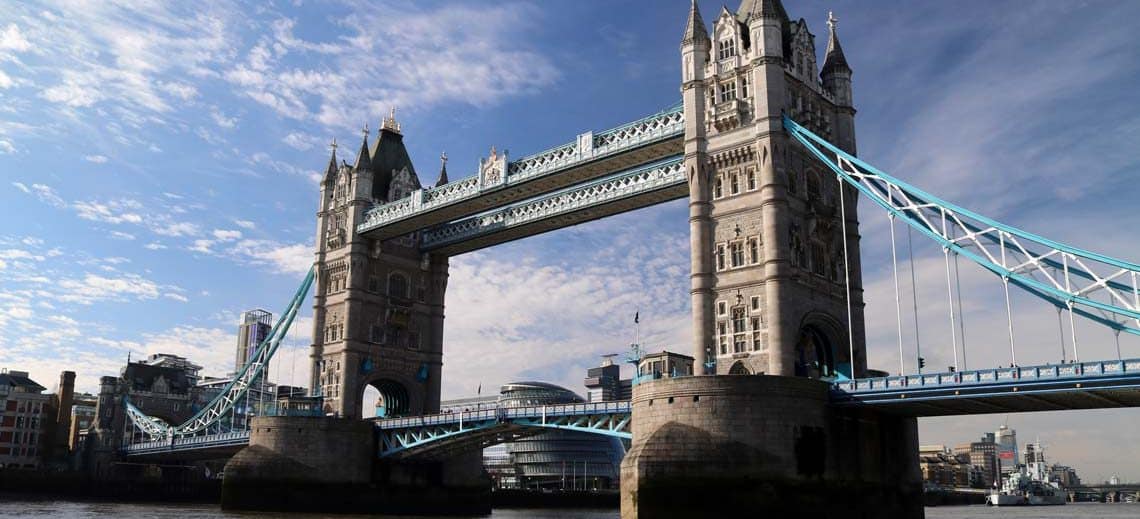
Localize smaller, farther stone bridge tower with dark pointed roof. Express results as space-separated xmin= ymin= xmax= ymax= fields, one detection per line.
xmin=310 ymin=111 xmax=448 ymax=417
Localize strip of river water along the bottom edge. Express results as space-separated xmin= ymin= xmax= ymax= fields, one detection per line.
xmin=0 ymin=501 xmax=1140 ymax=519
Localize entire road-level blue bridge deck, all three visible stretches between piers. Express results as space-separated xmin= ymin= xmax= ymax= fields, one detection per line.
xmin=125 ymin=359 xmax=1140 ymax=461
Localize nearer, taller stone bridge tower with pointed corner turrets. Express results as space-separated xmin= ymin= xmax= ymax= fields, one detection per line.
xmin=681 ymin=0 xmax=866 ymax=378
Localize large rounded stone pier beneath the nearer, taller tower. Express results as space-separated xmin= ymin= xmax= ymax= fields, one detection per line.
xmin=621 ymin=375 xmax=923 ymax=519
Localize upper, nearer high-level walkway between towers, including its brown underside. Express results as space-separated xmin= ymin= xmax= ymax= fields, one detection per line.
xmin=357 ymin=105 xmax=687 ymax=244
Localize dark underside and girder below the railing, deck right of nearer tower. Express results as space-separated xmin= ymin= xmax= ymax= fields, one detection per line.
xmin=834 ymin=375 xmax=1140 ymax=416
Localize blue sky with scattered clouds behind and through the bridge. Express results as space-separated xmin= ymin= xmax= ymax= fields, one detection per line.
xmin=0 ymin=0 xmax=1140 ymax=481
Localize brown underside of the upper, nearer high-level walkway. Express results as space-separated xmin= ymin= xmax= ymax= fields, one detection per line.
xmin=363 ymin=135 xmax=684 ymax=241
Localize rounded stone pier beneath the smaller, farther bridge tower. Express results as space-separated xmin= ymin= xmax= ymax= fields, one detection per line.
xmin=221 ymin=416 xmax=490 ymax=516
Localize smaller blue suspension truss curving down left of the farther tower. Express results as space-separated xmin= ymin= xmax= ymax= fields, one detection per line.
xmin=124 ymin=267 xmax=316 ymax=440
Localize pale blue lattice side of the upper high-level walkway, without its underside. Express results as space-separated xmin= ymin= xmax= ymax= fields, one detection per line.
xmin=357 ymin=104 xmax=685 ymax=233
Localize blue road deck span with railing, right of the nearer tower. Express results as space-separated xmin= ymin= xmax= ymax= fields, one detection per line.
xmin=831 ymin=359 xmax=1140 ymax=416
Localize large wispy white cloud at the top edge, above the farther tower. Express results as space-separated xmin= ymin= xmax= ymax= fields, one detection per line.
xmin=223 ymin=3 xmax=560 ymax=127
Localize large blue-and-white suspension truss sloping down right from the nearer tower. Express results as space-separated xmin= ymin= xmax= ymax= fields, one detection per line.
xmin=783 ymin=116 xmax=1140 ymax=335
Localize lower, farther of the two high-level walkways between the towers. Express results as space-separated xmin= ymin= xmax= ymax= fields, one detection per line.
xmin=423 ymin=155 xmax=686 ymax=250
